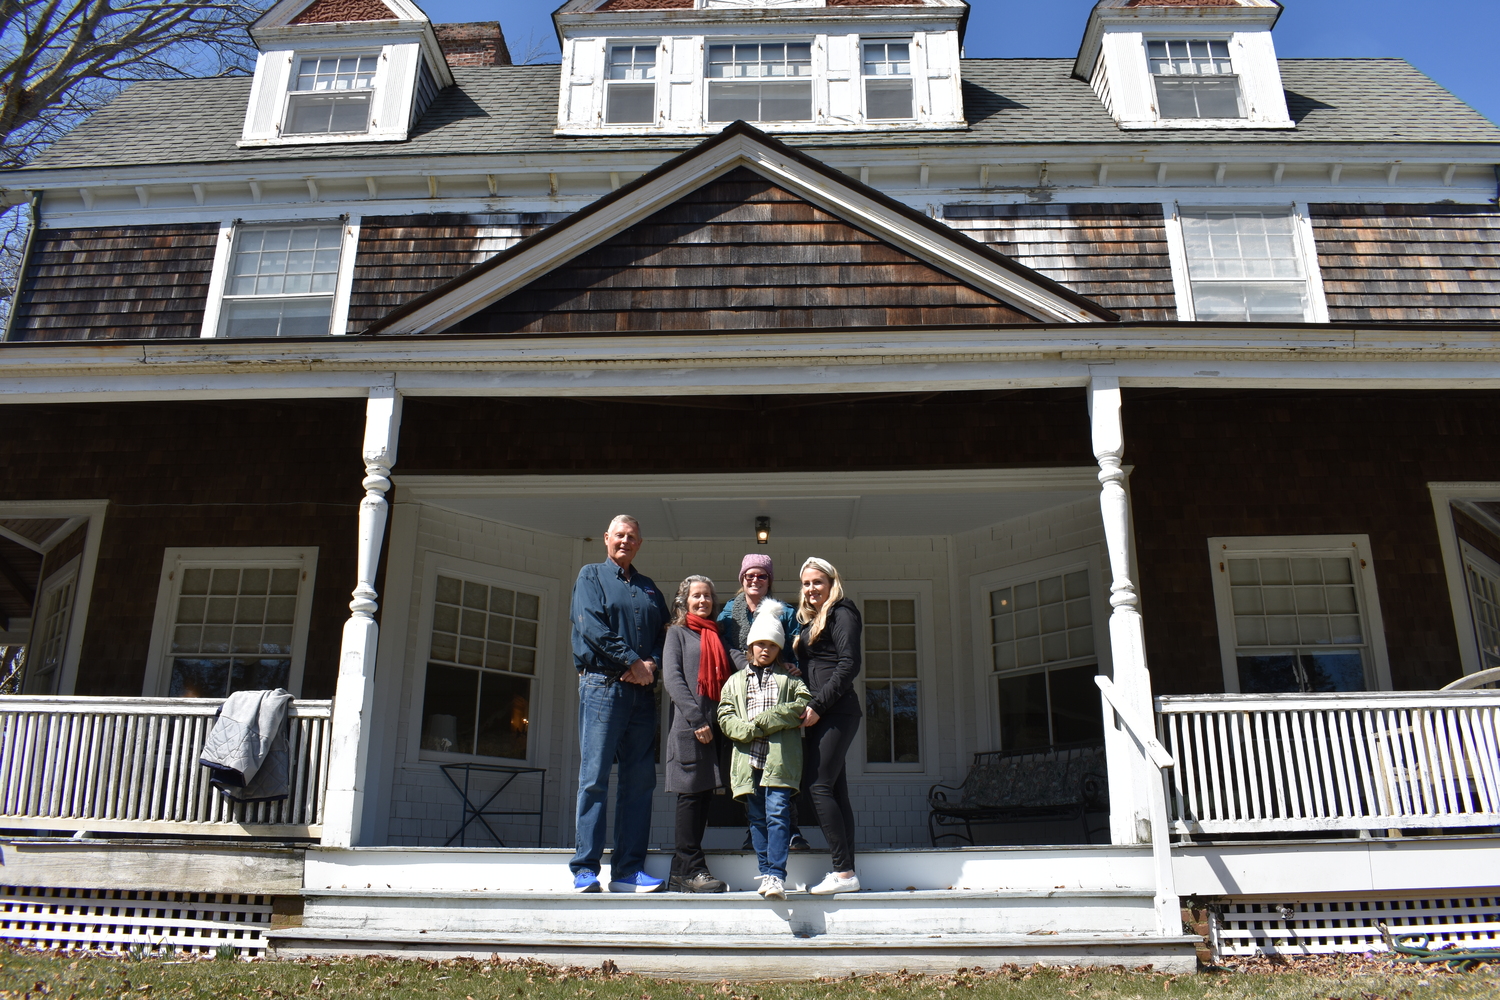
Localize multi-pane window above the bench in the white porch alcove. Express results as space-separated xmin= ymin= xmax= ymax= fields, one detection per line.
xmin=990 ymin=570 xmax=1104 ymax=750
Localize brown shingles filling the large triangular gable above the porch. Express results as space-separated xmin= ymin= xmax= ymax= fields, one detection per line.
xmin=453 ymin=168 xmax=1035 ymax=333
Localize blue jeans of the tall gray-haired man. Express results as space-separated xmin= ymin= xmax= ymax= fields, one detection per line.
xmin=569 ymin=672 xmax=657 ymax=879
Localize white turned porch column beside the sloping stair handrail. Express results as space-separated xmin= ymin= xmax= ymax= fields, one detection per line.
xmin=1089 ymin=375 xmax=1167 ymax=844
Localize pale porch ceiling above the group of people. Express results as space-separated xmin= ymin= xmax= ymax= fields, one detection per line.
xmin=395 ymin=466 xmax=1100 ymax=541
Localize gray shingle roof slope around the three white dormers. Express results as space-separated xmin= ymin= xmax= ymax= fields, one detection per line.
xmin=14 ymin=58 xmax=1500 ymax=169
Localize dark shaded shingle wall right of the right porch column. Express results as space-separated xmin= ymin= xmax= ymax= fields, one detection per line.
xmin=1125 ymin=390 xmax=1500 ymax=694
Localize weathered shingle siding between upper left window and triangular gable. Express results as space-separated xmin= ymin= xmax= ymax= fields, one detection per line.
xmin=348 ymin=213 xmax=566 ymax=333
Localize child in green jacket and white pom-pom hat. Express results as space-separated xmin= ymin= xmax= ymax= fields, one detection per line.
xmin=719 ymin=605 xmax=813 ymax=900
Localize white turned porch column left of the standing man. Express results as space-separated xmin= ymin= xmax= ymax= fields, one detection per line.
xmin=323 ymin=387 xmax=401 ymax=847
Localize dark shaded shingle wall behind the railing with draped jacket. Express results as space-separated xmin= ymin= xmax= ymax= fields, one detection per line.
xmin=0 ymin=400 xmax=366 ymax=699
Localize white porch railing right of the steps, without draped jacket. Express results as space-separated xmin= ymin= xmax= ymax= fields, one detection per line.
xmin=1157 ymin=691 xmax=1500 ymax=835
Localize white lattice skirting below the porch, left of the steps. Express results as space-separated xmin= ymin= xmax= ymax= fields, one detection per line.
xmin=0 ymin=886 xmax=272 ymax=958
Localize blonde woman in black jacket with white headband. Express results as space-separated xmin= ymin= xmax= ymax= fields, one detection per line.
xmin=795 ymin=556 xmax=864 ymax=895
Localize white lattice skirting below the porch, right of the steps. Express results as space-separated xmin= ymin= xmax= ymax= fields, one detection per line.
xmin=1209 ymin=888 xmax=1500 ymax=958
